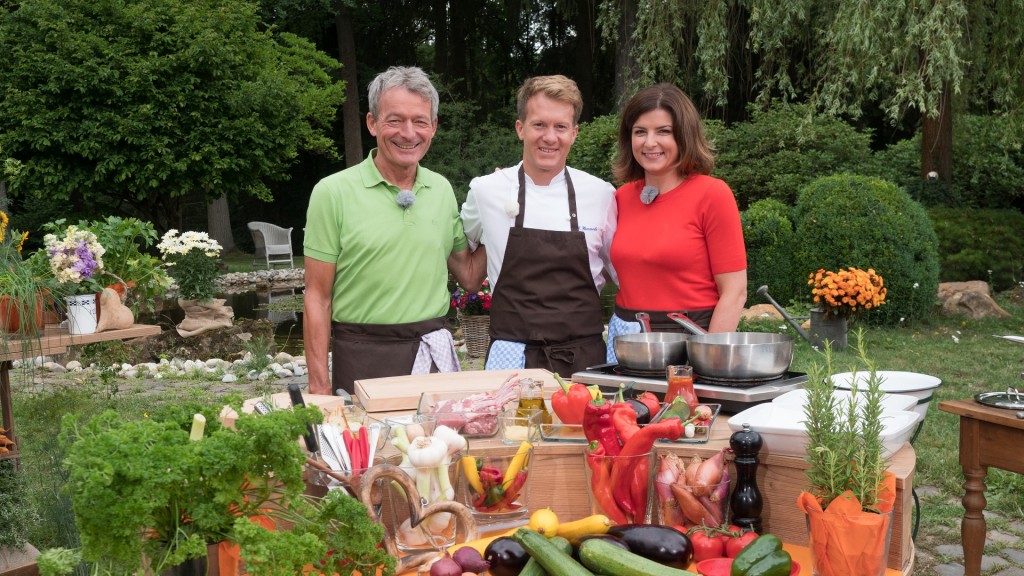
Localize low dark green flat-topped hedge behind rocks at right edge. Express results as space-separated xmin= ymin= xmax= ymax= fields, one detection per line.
xmin=928 ymin=204 xmax=1024 ymax=291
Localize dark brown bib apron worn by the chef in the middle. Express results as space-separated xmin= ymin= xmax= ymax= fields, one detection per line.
xmin=490 ymin=166 xmax=605 ymax=376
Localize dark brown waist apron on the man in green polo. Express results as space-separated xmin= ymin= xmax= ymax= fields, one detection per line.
xmin=331 ymin=317 xmax=446 ymax=394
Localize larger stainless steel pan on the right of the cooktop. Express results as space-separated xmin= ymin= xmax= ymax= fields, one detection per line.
xmin=669 ymin=313 xmax=794 ymax=380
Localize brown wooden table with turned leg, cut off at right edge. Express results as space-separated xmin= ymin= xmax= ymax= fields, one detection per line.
xmin=939 ymin=400 xmax=1024 ymax=576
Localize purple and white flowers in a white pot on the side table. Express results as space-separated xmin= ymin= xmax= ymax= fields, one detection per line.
xmin=43 ymin=224 xmax=105 ymax=334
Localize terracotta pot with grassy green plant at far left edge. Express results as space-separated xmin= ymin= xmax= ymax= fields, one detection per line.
xmin=0 ymin=210 xmax=53 ymax=336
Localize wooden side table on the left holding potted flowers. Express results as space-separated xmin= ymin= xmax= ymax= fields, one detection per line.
xmin=0 ymin=324 xmax=160 ymax=460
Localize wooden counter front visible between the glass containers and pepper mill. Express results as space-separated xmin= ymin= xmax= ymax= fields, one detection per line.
xmin=362 ymin=405 xmax=916 ymax=574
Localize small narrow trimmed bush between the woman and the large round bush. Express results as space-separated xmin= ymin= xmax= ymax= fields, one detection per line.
xmin=740 ymin=198 xmax=805 ymax=306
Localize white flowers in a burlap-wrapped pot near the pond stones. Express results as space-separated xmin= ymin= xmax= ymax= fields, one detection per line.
xmin=157 ymin=229 xmax=234 ymax=337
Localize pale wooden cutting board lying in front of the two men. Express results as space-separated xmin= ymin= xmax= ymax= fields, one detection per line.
xmin=355 ymin=368 xmax=558 ymax=412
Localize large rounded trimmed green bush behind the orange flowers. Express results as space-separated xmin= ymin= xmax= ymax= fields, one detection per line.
xmin=794 ymin=174 xmax=939 ymax=324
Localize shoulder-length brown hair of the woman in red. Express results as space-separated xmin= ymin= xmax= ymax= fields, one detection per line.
xmin=611 ymin=84 xmax=715 ymax=182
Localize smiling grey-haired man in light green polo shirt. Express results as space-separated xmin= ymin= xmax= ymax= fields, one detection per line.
xmin=302 ymin=67 xmax=483 ymax=394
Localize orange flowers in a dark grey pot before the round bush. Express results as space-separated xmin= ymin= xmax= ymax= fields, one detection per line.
xmin=807 ymin=266 xmax=886 ymax=349
